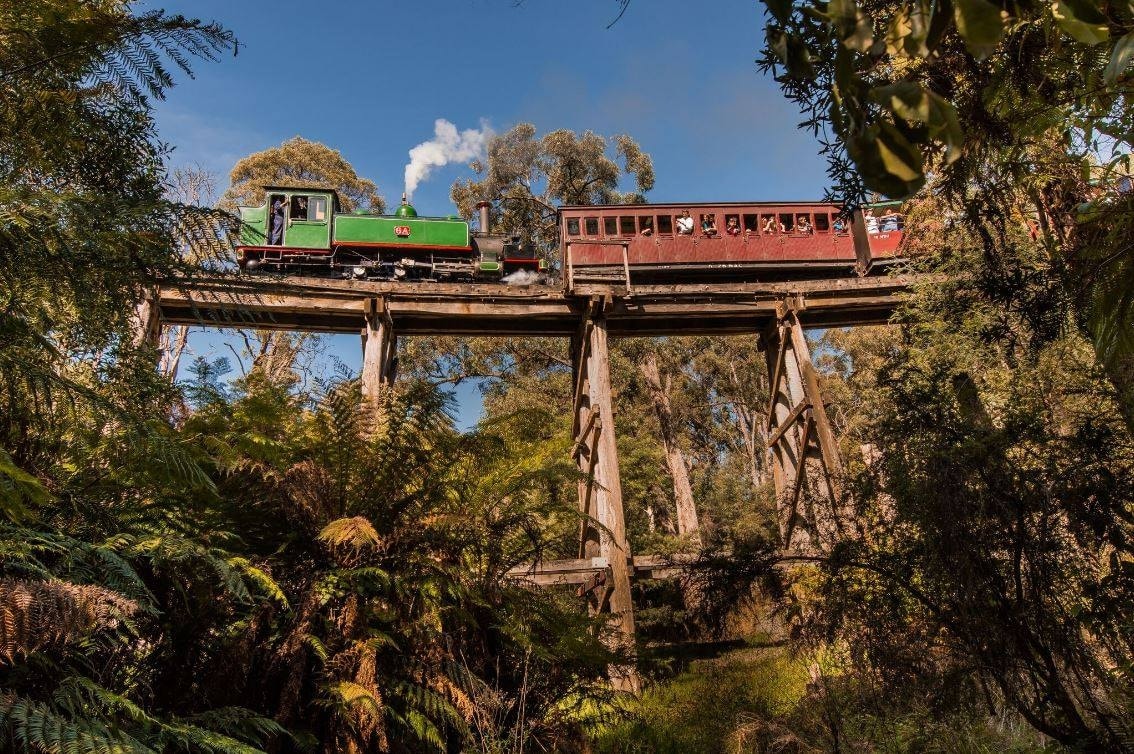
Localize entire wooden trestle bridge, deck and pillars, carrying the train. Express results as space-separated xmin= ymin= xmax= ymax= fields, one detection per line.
xmin=137 ymin=268 xmax=917 ymax=689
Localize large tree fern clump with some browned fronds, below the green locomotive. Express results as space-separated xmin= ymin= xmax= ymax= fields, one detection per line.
xmin=176 ymin=373 xmax=625 ymax=752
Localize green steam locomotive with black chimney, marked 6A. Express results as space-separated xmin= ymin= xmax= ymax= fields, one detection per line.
xmin=236 ymin=186 xmax=547 ymax=282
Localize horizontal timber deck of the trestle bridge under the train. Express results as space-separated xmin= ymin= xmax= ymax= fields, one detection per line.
xmin=159 ymin=270 xmax=923 ymax=337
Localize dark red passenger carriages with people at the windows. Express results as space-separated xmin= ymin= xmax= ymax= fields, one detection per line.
xmin=559 ymin=202 xmax=902 ymax=282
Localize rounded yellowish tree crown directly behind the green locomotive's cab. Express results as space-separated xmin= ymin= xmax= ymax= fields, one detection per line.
xmin=219 ymin=136 xmax=386 ymax=213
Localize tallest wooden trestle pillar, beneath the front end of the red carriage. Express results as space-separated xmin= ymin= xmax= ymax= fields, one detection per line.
xmin=572 ymin=297 xmax=641 ymax=693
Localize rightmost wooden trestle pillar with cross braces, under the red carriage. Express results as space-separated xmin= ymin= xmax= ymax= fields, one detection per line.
xmin=762 ymin=297 xmax=849 ymax=552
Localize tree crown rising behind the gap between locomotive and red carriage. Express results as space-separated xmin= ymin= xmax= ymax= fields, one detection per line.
xmin=450 ymin=124 xmax=654 ymax=254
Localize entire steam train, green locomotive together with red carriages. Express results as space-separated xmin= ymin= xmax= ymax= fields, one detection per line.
xmin=236 ymin=186 xmax=903 ymax=282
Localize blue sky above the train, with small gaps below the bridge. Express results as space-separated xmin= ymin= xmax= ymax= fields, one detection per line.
xmin=145 ymin=0 xmax=824 ymax=425
